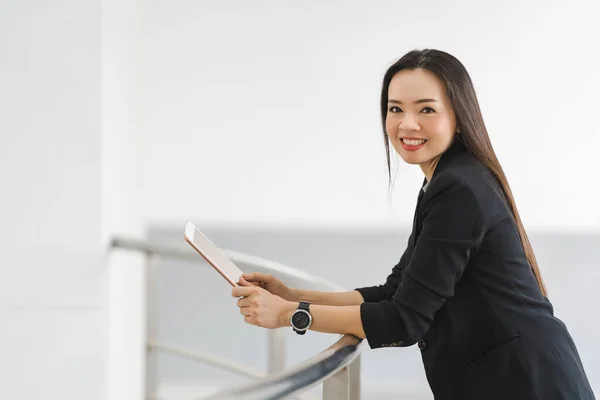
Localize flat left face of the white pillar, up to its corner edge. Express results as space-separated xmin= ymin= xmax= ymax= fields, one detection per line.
xmin=0 ymin=0 xmax=106 ymax=400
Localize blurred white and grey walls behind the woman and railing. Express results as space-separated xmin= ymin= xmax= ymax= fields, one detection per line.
xmin=0 ymin=0 xmax=600 ymax=400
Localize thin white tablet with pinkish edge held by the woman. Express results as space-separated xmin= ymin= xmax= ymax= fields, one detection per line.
xmin=184 ymin=221 xmax=242 ymax=286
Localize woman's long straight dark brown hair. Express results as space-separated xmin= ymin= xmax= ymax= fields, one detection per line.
xmin=381 ymin=49 xmax=547 ymax=296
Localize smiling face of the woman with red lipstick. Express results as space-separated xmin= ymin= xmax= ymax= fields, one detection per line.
xmin=385 ymin=69 xmax=456 ymax=180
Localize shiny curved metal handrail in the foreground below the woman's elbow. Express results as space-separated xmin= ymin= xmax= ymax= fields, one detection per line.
xmin=198 ymin=335 xmax=362 ymax=400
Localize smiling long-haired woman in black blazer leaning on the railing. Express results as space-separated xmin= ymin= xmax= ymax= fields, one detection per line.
xmin=232 ymin=50 xmax=594 ymax=400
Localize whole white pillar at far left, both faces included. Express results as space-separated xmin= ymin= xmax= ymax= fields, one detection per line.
xmin=0 ymin=0 xmax=145 ymax=400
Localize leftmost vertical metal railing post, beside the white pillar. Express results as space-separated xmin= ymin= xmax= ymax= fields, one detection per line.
xmin=145 ymin=252 xmax=159 ymax=399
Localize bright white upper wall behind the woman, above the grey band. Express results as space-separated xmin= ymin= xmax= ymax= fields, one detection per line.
xmin=142 ymin=0 xmax=600 ymax=231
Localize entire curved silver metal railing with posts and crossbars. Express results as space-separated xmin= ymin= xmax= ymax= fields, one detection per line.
xmin=111 ymin=237 xmax=361 ymax=400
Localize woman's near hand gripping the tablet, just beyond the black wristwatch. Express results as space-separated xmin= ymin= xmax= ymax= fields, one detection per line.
xmin=231 ymin=274 xmax=297 ymax=329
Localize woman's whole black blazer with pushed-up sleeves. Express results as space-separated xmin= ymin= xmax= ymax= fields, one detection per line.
xmin=357 ymin=140 xmax=594 ymax=400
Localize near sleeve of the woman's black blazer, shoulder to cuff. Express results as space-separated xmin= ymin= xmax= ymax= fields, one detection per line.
xmin=360 ymin=175 xmax=486 ymax=348
